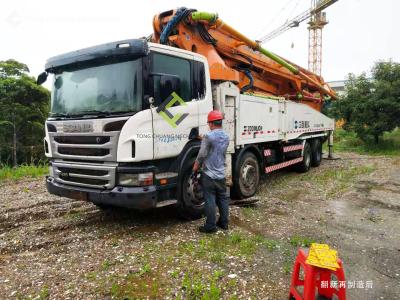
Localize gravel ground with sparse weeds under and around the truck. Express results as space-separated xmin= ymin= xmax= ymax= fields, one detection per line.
xmin=0 ymin=153 xmax=400 ymax=299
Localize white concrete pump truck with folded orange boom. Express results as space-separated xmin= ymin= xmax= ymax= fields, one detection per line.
xmin=38 ymin=8 xmax=335 ymax=218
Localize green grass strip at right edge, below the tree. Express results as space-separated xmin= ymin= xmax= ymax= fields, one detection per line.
xmin=328 ymin=129 xmax=400 ymax=156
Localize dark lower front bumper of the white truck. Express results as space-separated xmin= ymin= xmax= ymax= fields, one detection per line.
xmin=46 ymin=176 xmax=158 ymax=209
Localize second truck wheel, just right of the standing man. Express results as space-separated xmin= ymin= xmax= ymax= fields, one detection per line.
xmin=233 ymin=151 xmax=260 ymax=199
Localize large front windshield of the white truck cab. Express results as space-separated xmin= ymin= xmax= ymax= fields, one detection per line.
xmin=51 ymin=59 xmax=142 ymax=116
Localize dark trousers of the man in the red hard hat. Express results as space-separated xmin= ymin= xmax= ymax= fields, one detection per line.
xmin=201 ymin=173 xmax=229 ymax=229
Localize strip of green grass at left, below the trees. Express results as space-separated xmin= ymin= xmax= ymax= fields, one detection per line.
xmin=0 ymin=165 xmax=49 ymax=181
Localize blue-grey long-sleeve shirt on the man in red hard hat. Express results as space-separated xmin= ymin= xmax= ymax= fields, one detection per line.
xmin=196 ymin=128 xmax=229 ymax=179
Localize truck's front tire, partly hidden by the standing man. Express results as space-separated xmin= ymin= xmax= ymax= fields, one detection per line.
xmin=177 ymin=157 xmax=204 ymax=220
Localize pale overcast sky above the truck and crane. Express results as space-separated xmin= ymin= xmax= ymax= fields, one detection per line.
xmin=0 ymin=0 xmax=400 ymax=81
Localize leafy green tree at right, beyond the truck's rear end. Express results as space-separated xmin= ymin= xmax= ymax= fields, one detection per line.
xmin=333 ymin=61 xmax=400 ymax=144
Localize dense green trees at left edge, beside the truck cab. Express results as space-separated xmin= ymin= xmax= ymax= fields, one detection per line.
xmin=0 ymin=59 xmax=50 ymax=166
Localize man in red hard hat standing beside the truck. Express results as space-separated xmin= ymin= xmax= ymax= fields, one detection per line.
xmin=193 ymin=110 xmax=229 ymax=233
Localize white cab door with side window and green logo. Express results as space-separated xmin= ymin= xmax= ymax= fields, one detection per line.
xmin=151 ymin=52 xmax=199 ymax=159
